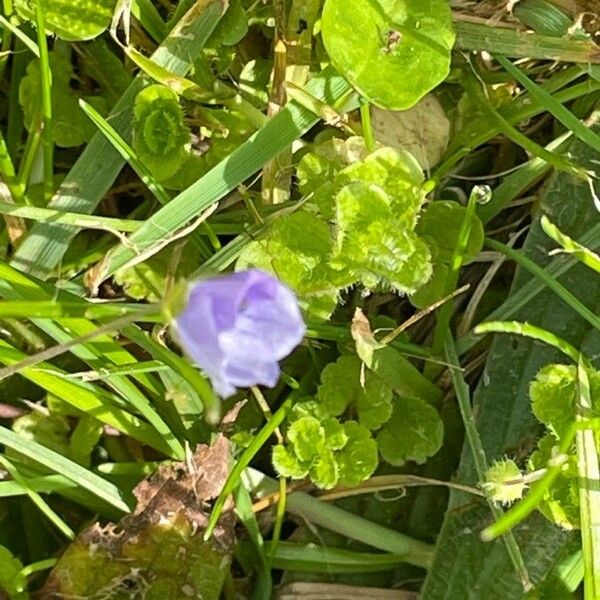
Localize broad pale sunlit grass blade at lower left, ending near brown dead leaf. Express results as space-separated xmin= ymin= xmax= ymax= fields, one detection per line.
xmin=0 ymin=426 xmax=129 ymax=513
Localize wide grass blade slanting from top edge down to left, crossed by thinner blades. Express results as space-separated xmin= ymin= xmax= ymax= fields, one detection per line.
xmin=12 ymin=0 xmax=226 ymax=279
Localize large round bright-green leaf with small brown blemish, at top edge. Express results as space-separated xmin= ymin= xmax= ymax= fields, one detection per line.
xmin=322 ymin=0 xmax=455 ymax=110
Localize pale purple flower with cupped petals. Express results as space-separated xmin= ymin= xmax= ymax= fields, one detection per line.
xmin=175 ymin=269 xmax=306 ymax=398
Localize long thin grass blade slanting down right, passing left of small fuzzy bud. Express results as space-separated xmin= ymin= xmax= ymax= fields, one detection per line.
xmin=445 ymin=329 xmax=533 ymax=591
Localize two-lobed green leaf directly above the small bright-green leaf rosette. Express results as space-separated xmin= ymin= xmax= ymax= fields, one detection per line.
xmin=318 ymin=355 xmax=393 ymax=429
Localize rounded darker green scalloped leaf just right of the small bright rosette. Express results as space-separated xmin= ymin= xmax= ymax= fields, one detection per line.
xmin=377 ymin=398 xmax=444 ymax=467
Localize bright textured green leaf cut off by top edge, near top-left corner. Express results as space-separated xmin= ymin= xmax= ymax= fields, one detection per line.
xmin=14 ymin=0 xmax=117 ymax=42
